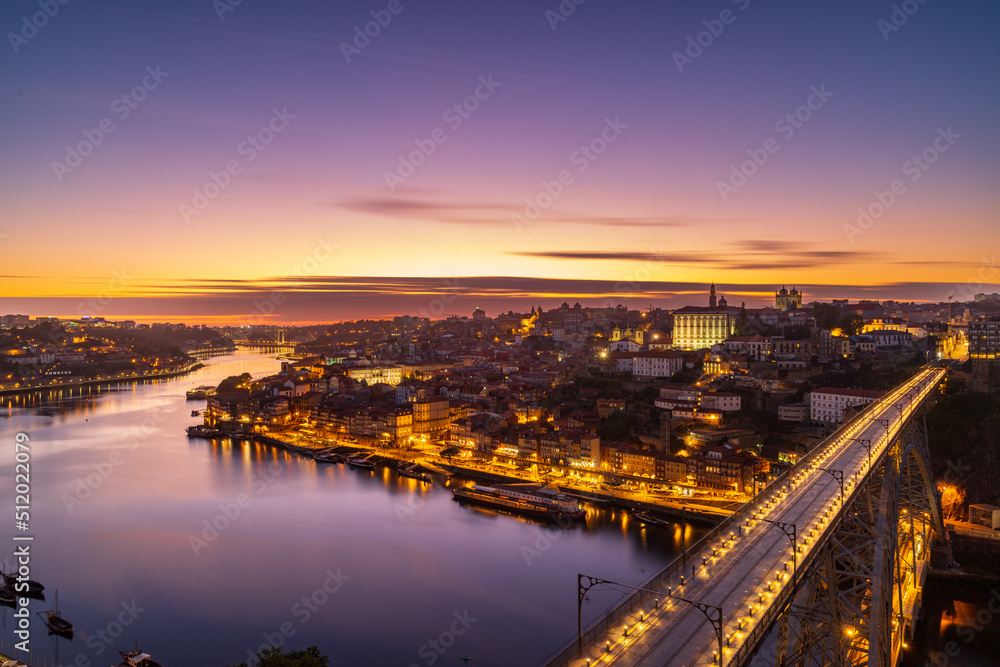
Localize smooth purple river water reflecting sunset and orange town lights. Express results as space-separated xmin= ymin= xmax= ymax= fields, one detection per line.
xmin=0 ymin=353 xmax=700 ymax=667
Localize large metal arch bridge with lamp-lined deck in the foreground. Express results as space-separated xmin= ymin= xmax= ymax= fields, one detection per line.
xmin=543 ymin=366 xmax=945 ymax=667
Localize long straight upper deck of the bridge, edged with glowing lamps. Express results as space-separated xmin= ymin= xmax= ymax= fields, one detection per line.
xmin=570 ymin=369 xmax=944 ymax=667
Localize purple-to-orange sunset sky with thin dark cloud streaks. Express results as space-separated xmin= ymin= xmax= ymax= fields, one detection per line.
xmin=0 ymin=0 xmax=1000 ymax=324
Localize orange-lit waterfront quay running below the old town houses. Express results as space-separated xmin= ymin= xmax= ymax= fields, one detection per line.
xmin=246 ymin=434 xmax=733 ymax=525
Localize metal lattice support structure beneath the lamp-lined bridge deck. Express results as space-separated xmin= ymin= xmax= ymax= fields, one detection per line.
xmin=775 ymin=404 xmax=944 ymax=667
